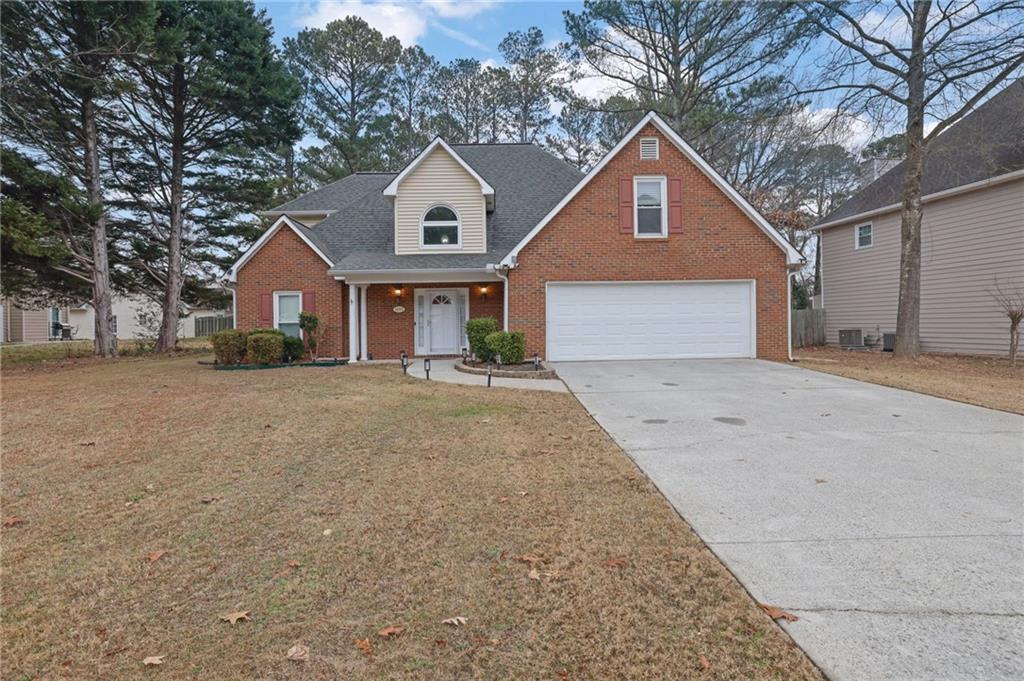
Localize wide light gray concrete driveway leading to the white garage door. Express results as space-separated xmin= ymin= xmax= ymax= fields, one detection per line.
xmin=556 ymin=359 xmax=1024 ymax=679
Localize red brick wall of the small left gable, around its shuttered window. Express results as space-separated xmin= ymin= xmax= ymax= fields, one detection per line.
xmin=236 ymin=226 xmax=348 ymax=357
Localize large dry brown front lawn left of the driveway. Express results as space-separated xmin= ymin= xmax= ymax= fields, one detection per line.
xmin=0 ymin=357 xmax=821 ymax=679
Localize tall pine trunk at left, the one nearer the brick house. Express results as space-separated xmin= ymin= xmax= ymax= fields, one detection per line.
xmin=156 ymin=63 xmax=185 ymax=352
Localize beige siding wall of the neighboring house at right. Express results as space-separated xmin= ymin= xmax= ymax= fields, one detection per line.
xmin=821 ymin=180 xmax=1024 ymax=354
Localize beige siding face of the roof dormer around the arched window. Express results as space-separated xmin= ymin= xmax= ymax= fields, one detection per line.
xmin=394 ymin=146 xmax=487 ymax=255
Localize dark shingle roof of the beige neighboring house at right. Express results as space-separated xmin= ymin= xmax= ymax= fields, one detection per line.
xmin=819 ymin=80 xmax=1024 ymax=224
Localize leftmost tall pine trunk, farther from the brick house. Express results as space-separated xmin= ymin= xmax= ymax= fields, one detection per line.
xmin=82 ymin=95 xmax=118 ymax=357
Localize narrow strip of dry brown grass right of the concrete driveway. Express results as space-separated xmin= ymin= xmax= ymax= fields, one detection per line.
xmin=794 ymin=347 xmax=1024 ymax=414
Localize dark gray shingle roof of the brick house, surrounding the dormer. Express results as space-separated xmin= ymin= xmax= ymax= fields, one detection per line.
xmin=273 ymin=144 xmax=583 ymax=270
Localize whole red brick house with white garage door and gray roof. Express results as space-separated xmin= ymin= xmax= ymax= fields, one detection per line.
xmin=226 ymin=113 xmax=801 ymax=360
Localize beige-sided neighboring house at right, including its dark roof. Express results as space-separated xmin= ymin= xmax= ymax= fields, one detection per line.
xmin=817 ymin=81 xmax=1024 ymax=354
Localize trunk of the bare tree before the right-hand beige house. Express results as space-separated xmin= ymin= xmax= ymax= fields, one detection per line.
xmin=894 ymin=0 xmax=932 ymax=358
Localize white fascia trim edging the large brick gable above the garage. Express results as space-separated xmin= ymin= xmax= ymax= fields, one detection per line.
xmin=502 ymin=112 xmax=804 ymax=265
